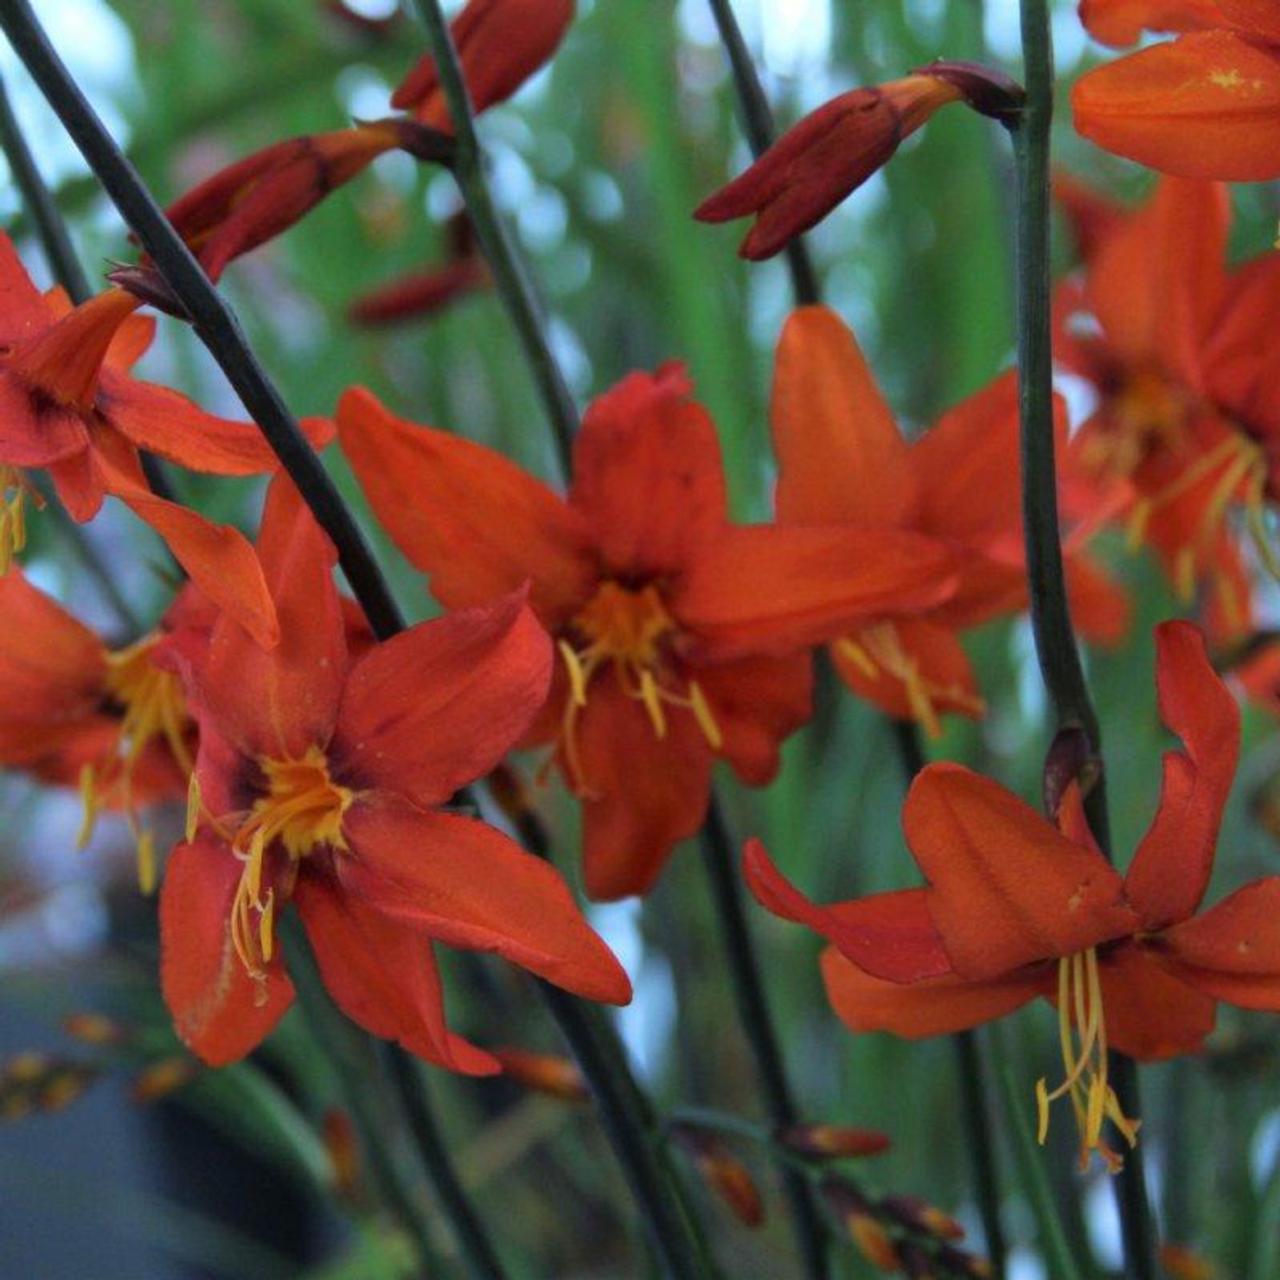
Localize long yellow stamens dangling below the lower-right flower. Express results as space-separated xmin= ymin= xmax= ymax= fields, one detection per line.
xmin=1036 ymin=947 xmax=1142 ymax=1174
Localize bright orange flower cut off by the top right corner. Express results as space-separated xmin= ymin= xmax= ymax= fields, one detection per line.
xmin=1071 ymin=0 xmax=1280 ymax=182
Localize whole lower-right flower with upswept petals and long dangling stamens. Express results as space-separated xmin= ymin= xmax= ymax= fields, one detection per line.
xmin=746 ymin=622 xmax=1280 ymax=1165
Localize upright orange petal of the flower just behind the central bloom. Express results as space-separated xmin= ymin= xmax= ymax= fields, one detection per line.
xmin=769 ymin=306 xmax=915 ymax=529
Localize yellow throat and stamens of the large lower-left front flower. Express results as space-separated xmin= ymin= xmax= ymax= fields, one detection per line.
xmin=194 ymin=745 xmax=356 ymax=988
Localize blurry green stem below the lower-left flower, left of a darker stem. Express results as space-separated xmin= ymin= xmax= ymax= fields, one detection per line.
xmin=280 ymin=914 xmax=443 ymax=1275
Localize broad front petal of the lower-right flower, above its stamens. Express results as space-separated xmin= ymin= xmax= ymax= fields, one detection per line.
xmin=902 ymin=764 xmax=1138 ymax=979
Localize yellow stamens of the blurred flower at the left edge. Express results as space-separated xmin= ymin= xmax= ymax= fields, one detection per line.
xmin=79 ymin=635 xmax=192 ymax=893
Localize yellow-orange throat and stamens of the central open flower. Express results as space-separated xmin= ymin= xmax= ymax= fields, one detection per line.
xmin=557 ymin=581 xmax=723 ymax=795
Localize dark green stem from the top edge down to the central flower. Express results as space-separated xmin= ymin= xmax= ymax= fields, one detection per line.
xmin=413 ymin=0 xmax=579 ymax=457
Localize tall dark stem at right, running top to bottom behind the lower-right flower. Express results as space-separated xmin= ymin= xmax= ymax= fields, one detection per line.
xmin=1012 ymin=0 xmax=1157 ymax=1280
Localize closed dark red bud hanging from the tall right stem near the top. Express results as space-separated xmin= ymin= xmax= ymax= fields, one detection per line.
xmin=694 ymin=63 xmax=1021 ymax=261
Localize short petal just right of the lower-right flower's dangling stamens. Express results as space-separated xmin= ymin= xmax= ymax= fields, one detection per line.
xmin=1090 ymin=943 xmax=1216 ymax=1062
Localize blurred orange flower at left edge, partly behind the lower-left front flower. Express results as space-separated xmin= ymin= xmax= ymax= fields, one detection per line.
xmin=0 ymin=570 xmax=205 ymax=892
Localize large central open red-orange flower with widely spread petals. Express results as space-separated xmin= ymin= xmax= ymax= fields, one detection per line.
xmin=338 ymin=366 xmax=955 ymax=899
